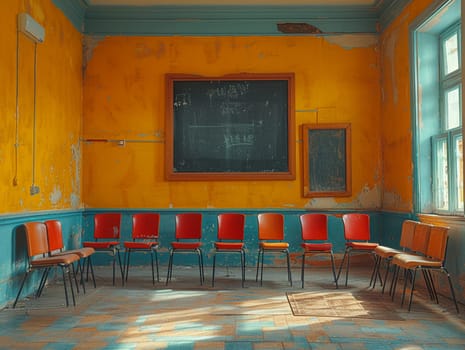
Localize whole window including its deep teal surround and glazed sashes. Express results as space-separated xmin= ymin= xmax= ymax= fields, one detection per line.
xmin=410 ymin=0 xmax=464 ymax=216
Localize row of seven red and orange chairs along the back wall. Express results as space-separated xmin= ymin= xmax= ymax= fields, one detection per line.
xmin=84 ymin=213 xmax=377 ymax=288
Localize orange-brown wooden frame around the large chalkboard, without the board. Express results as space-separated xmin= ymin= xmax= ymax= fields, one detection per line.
xmin=165 ymin=73 xmax=295 ymax=181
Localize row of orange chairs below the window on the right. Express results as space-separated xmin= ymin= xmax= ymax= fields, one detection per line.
xmin=370 ymin=220 xmax=459 ymax=313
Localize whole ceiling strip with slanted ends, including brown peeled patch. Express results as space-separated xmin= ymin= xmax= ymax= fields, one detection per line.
xmin=52 ymin=0 xmax=406 ymax=36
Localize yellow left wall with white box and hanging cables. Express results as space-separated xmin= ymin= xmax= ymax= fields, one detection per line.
xmin=0 ymin=0 xmax=82 ymax=213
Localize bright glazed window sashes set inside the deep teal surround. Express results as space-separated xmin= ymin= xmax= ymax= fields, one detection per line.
xmin=432 ymin=24 xmax=463 ymax=214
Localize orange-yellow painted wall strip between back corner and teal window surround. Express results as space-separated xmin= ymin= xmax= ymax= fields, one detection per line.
xmin=380 ymin=0 xmax=433 ymax=211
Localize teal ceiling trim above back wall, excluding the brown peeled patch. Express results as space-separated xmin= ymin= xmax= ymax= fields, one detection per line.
xmin=84 ymin=6 xmax=378 ymax=35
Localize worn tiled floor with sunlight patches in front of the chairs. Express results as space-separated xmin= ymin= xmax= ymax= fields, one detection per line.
xmin=0 ymin=266 xmax=465 ymax=350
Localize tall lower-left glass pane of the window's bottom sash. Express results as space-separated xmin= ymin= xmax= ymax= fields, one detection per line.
xmin=435 ymin=139 xmax=449 ymax=210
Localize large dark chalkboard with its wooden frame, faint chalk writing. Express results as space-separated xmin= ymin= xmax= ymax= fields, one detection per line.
xmin=165 ymin=74 xmax=295 ymax=180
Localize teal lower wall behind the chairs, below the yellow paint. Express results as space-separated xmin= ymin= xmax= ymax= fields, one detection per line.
xmin=5 ymin=209 xmax=465 ymax=307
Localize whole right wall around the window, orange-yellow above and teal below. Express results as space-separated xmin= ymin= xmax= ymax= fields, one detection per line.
xmin=380 ymin=0 xmax=465 ymax=301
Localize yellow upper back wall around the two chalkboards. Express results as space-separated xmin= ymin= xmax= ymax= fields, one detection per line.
xmin=82 ymin=35 xmax=382 ymax=209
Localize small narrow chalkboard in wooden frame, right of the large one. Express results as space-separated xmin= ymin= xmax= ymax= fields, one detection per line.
xmin=302 ymin=123 xmax=352 ymax=197
